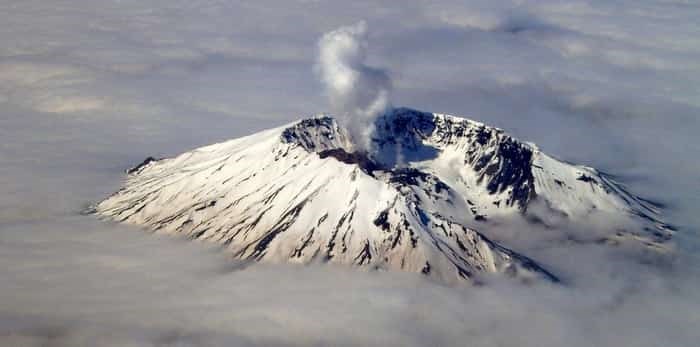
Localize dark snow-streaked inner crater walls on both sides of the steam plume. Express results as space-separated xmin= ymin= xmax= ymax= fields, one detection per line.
xmin=282 ymin=108 xmax=536 ymax=212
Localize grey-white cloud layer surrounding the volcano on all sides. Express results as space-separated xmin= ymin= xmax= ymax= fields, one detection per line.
xmin=0 ymin=0 xmax=700 ymax=346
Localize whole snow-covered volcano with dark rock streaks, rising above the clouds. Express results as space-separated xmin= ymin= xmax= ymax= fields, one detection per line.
xmin=95 ymin=109 xmax=672 ymax=281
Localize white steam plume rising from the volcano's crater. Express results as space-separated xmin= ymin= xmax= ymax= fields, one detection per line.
xmin=316 ymin=21 xmax=391 ymax=150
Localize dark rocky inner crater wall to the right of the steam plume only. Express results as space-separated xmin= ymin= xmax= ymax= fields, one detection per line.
xmin=374 ymin=109 xmax=536 ymax=211
